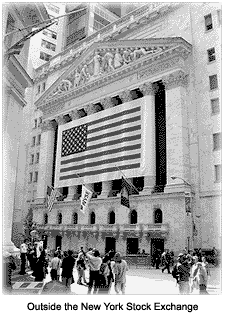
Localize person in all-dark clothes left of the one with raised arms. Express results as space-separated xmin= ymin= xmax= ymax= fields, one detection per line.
xmin=61 ymin=250 xmax=76 ymax=289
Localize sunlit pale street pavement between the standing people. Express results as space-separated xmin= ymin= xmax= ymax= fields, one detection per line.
xmin=12 ymin=268 xmax=221 ymax=295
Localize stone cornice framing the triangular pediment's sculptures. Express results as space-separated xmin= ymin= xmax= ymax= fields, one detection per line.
xmin=35 ymin=38 xmax=191 ymax=110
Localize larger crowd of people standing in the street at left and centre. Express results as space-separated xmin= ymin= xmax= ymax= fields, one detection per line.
xmin=19 ymin=240 xmax=128 ymax=294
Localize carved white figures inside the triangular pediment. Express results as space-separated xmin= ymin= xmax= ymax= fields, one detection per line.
xmin=50 ymin=46 xmax=163 ymax=96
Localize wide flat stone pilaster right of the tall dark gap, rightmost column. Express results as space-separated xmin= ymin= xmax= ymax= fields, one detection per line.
xmin=163 ymin=70 xmax=190 ymax=193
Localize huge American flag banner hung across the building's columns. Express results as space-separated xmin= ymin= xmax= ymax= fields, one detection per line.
xmin=55 ymin=98 xmax=155 ymax=187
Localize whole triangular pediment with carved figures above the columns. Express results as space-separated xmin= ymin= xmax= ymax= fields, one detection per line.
xmin=35 ymin=37 xmax=191 ymax=107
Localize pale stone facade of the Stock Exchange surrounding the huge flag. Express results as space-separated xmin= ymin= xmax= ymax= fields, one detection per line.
xmin=18 ymin=4 xmax=221 ymax=254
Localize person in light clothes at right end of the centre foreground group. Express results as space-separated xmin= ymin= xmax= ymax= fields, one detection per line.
xmin=113 ymin=252 xmax=128 ymax=294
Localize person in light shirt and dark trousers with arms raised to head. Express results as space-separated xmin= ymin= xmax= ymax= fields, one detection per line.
xmin=85 ymin=249 xmax=102 ymax=294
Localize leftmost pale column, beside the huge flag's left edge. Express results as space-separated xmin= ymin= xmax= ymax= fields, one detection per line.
xmin=36 ymin=121 xmax=56 ymax=203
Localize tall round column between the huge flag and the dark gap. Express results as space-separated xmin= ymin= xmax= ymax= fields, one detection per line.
xmin=139 ymin=82 xmax=156 ymax=195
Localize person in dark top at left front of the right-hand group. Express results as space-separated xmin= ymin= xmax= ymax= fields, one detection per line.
xmin=177 ymin=254 xmax=190 ymax=294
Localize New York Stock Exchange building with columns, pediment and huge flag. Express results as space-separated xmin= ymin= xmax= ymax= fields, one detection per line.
xmin=31 ymin=4 xmax=220 ymax=255
